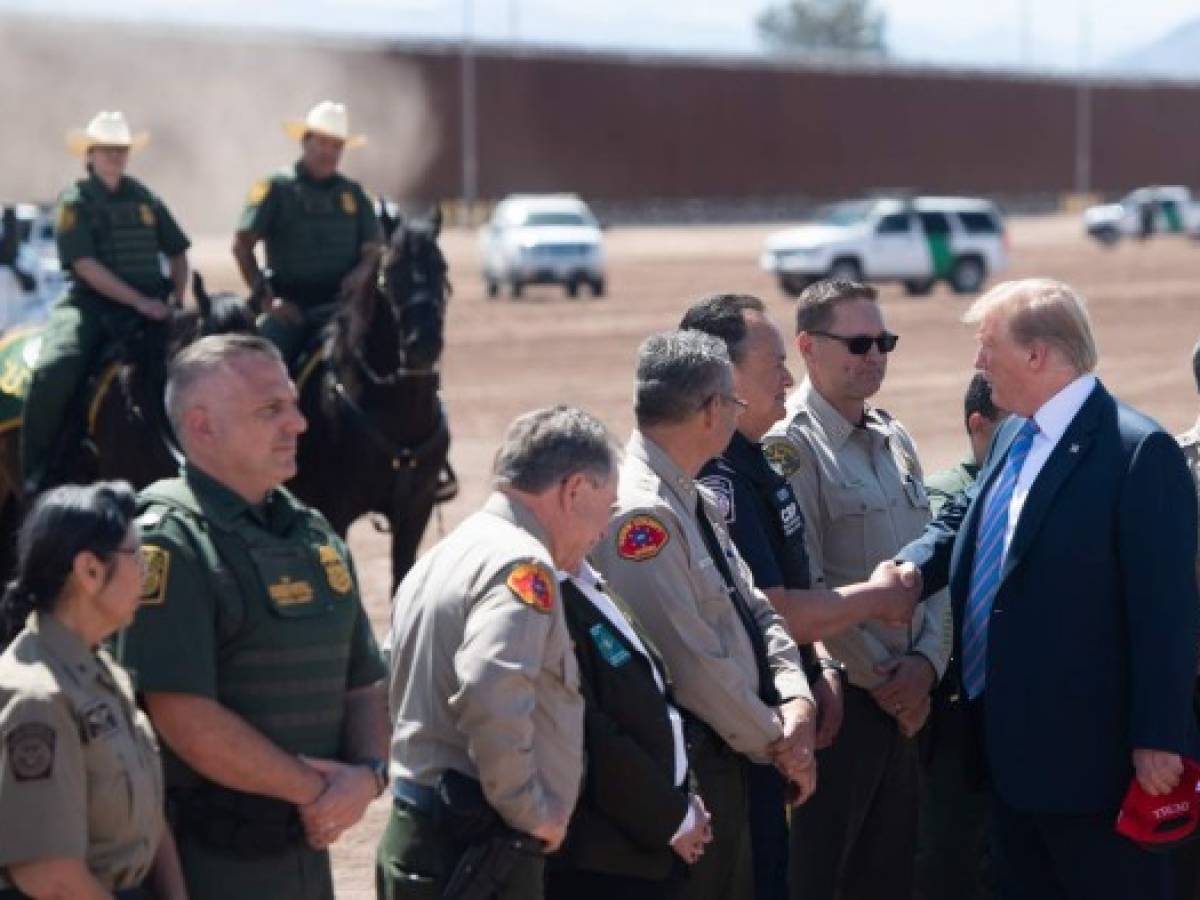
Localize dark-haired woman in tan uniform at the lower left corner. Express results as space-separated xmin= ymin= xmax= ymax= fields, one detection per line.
xmin=0 ymin=481 xmax=187 ymax=900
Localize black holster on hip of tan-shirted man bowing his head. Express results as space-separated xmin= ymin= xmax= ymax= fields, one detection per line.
xmin=433 ymin=769 xmax=542 ymax=900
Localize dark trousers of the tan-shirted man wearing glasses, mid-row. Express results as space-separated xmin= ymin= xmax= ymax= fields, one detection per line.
xmin=677 ymin=732 xmax=754 ymax=900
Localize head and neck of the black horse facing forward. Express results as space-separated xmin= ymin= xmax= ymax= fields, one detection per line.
xmin=334 ymin=206 xmax=450 ymax=385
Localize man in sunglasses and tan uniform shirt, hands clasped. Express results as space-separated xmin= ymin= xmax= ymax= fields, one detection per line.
xmin=763 ymin=281 xmax=952 ymax=900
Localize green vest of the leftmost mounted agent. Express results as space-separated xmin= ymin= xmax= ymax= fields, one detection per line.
xmin=72 ymin=176 xmax=166 ymax=306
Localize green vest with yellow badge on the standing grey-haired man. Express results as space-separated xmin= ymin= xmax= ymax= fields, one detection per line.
xmin=138 ymin=478 xmax=359 ymax=758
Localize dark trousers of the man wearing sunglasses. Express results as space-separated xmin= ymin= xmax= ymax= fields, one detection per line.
xmin=790 ymin=686 xmax=918 ymax=900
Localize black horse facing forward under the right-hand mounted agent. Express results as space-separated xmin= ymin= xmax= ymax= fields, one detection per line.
xmin=289 ymin=209 xmax=456 ymax=595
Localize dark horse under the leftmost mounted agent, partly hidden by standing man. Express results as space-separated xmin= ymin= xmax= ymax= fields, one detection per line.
xmin=0 ymin=272 xmax=254 ymax=577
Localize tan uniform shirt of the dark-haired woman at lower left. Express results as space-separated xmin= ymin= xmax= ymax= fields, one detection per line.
xmin=0 ymin=613 xmax=163 ymax=890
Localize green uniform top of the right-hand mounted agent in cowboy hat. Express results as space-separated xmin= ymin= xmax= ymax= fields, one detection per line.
xmin=238 ymin=162 xmax=383 ymax=361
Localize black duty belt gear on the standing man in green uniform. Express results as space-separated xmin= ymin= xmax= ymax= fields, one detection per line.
xmin=168 ymin=785 xmax=304 ymax=859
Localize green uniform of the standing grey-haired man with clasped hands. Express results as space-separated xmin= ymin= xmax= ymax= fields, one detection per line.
xmin=124 ymin=463 xmax=386 ymax=900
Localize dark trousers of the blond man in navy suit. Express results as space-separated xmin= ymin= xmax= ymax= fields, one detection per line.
xmin=992 ymin=798 xmax=1171 ymax=900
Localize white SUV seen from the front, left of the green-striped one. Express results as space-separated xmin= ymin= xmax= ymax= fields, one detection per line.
xmin=479 ymin=194 xmax=605 ymax=298
